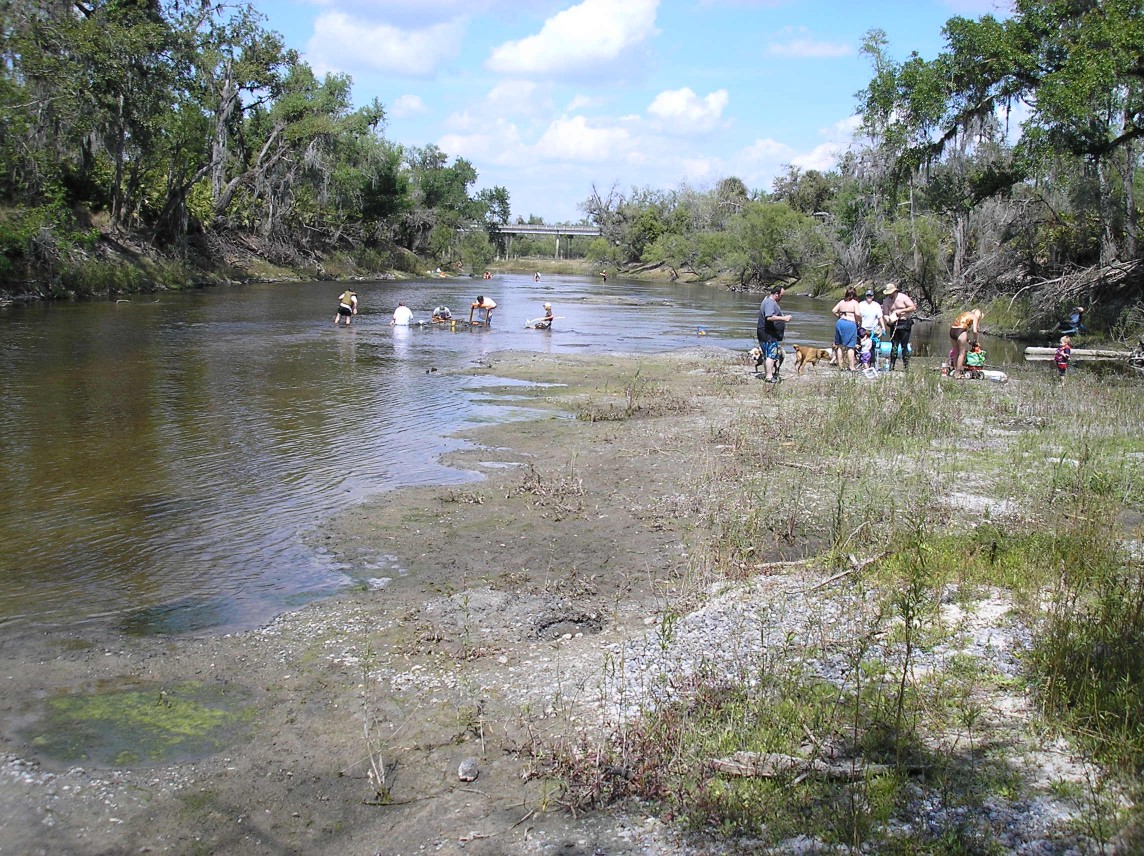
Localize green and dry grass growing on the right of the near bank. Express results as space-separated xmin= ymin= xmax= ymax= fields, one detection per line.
xmin=535 ymin=359 xmax=1144 ymax=853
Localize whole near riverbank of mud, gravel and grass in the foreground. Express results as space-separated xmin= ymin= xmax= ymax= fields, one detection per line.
xmin=0 ymin=349 xmax=1144 ymax=854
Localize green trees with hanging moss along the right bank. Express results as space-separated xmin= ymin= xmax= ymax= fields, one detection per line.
xmin=581 ymin=0 xmax=1144 ymax=333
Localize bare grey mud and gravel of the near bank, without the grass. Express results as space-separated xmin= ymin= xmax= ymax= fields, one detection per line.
xmin=0 ymin=349 xmax=1139 ymax=855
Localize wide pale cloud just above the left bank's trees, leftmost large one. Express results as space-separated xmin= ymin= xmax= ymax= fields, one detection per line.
xmin=307 ymin=13 xmax=464 ymax=77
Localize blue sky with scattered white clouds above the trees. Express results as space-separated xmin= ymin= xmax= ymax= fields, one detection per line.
xmin=243 ymin=0 xmax=1008 ymax=223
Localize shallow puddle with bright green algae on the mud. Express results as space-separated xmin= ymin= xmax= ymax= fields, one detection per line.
xmin=29 ymin=682 xmax=254 ymax=767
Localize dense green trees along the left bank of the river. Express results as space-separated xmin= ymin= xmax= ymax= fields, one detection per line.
xmin=0 ymin=0 xmax=509 ymax=289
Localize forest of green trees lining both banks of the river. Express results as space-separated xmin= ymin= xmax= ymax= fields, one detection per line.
xmin=0 ymin=0 xmax=1144 ymax=341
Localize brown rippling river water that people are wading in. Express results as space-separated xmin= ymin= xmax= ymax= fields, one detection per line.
xmin=0 ymin=275 xmax=1011 ymax=632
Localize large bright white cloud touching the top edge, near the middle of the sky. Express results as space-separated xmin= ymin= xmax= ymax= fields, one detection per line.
xmin=485 ymin=0 xmax=659 ymax=77
